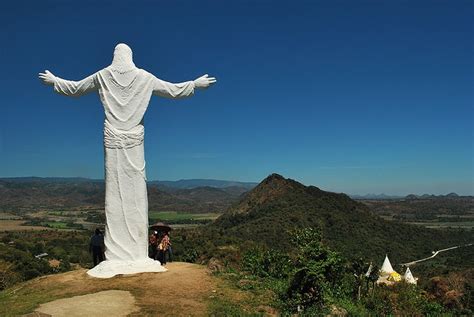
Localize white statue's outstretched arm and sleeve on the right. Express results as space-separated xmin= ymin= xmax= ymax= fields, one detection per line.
xmin=153 ymin=74 xmax=216 ymax=98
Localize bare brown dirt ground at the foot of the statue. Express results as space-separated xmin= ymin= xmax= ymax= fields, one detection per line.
xmin=10 ymin=262 xmax=216 ymax=316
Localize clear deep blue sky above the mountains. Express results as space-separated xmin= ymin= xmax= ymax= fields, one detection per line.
xmin=0 ymin=0 xmax=474 ymax=194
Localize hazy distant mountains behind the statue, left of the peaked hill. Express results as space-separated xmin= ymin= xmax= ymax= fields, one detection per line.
xmin=0 ymin=177 xmax=252 ymax=214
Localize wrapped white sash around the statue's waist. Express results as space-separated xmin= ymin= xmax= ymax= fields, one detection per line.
xmin=104 ymin=121 xmax=145 ymax=149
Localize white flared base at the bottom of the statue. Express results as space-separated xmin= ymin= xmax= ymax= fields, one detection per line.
xmin=87 ymin=258 xmax=167 ymax=278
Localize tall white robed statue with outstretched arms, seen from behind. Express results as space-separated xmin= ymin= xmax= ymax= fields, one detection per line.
xmin=39 ymin=44 xmax=216 ymax=278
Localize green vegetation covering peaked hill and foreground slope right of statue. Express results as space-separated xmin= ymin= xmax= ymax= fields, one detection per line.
xmin=168 ymin=174 xmax=474 ymax=316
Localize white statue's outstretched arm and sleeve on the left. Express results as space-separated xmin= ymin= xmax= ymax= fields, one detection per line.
xmin=39 ymin=70 xmax=98 ymax=97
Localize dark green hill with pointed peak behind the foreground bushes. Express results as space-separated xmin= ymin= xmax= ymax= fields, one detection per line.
xmin=212 ymin=174 xmax=474 ymax=263
